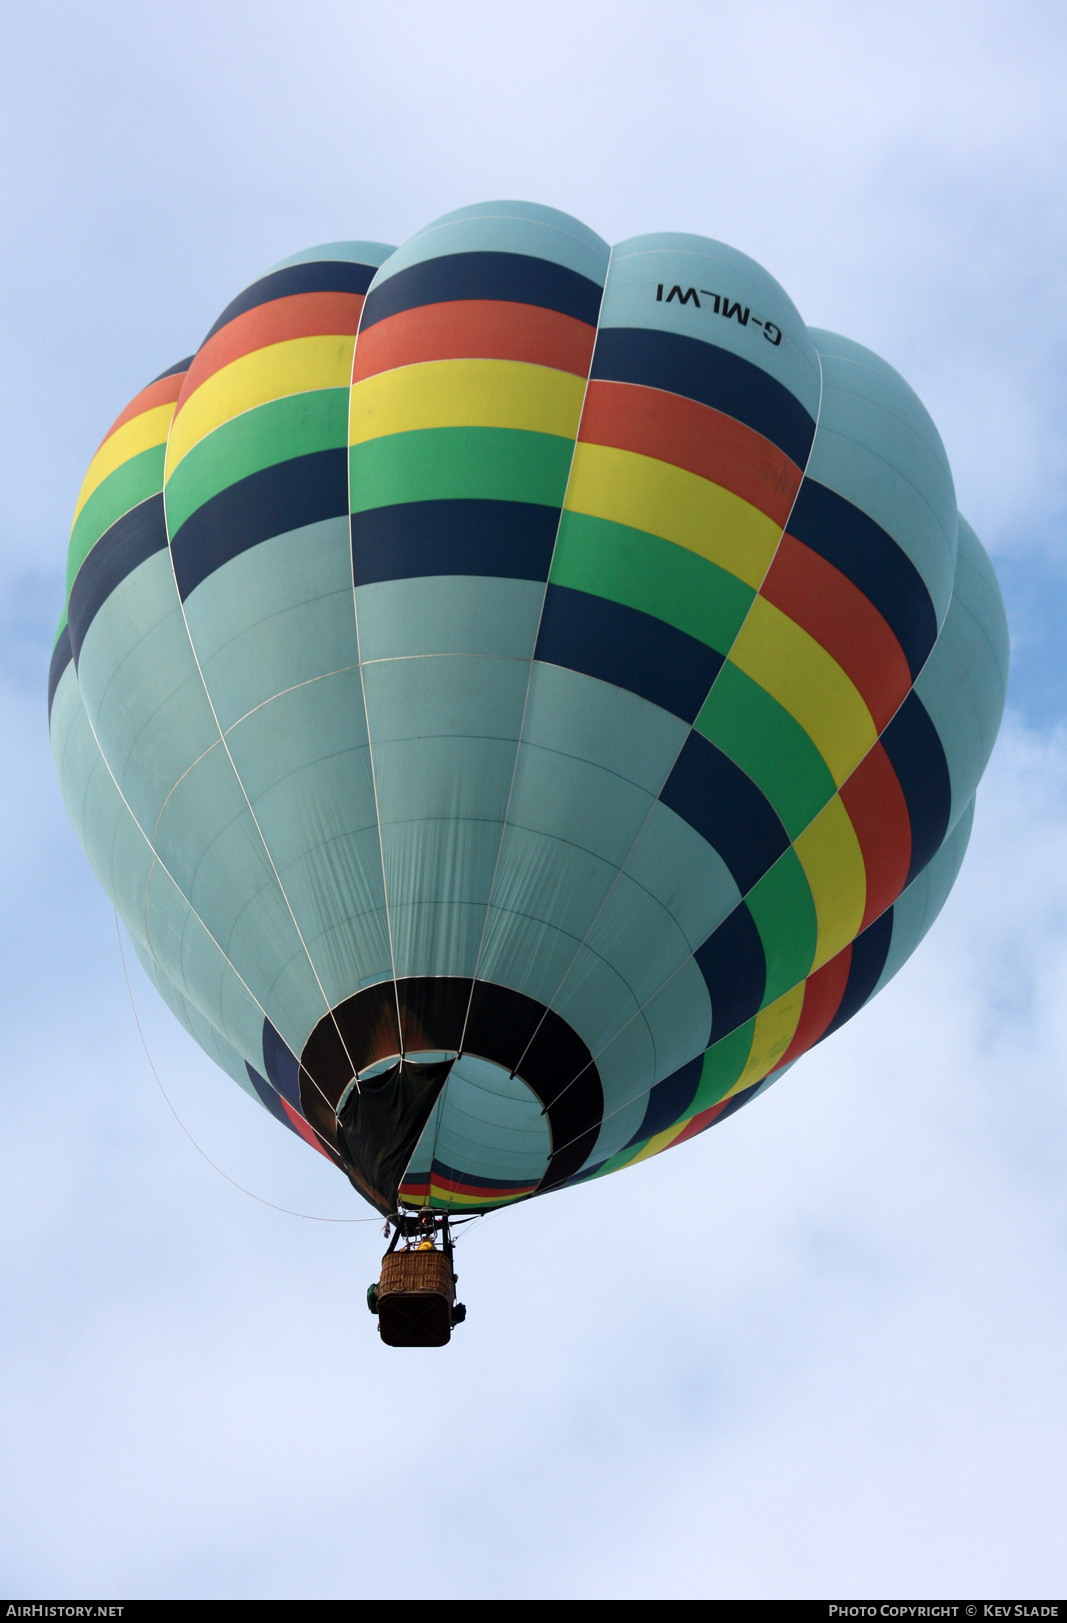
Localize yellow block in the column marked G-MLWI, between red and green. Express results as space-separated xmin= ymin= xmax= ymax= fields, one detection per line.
xmin=565 ymin=443 xmax=781 ymax=586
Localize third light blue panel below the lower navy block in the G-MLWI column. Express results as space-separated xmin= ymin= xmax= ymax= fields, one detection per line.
xmin=483 ymin=820 xmax=619 ymax=941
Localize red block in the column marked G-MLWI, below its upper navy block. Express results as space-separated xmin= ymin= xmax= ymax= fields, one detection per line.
xmin=578 ymin=378 xmax=801 ymax=524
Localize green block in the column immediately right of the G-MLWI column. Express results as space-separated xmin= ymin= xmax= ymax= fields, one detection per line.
xmin=695 ymin=661 xmax=836 ymax=839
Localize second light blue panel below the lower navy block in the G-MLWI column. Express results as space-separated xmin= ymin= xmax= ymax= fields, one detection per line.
xmin=508 ymin=743 xmax=653 ymax=883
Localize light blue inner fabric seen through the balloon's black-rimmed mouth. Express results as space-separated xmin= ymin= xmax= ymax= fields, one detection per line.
xmin=413 ymin=1053 xmax=552 ymax=1183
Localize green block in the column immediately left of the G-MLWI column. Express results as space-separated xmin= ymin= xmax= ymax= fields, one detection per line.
xmin=349 ymin=428 xmax=573 ymax=513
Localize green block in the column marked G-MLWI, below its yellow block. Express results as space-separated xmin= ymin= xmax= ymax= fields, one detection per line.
xmin=549 ymin=513 xmax=750 ymax=652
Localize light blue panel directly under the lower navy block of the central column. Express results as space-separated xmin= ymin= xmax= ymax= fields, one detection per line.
xmin=356 ymin=575 xmax=544 ymax=665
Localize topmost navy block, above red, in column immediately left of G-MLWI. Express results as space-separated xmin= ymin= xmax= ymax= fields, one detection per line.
xmin=359 ymin=252 xmax=603 ymax=333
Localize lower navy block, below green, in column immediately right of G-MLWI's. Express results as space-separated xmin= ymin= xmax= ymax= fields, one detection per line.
xmin=659 ymin=732 xmax=789 ymax=896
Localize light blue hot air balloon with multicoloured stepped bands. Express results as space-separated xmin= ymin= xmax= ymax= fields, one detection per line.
xmin=49 ymin=203 xmax=1009 ymax=1339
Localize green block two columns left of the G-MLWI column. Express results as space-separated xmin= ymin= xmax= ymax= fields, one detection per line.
xmin=167 ymin=388 xmax=348 ymax=536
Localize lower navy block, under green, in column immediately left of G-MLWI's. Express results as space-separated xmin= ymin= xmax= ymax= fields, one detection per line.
xmin=352 ymin=498 xmax=559 ymax=586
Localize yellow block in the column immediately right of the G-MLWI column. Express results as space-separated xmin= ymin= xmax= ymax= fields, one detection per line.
xmin=729 ymin=597 xmax=879 ymax=787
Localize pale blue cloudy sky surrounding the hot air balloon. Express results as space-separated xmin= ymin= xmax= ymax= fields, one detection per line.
xmin=0 ymin=0 xmax=1067 ymax=1599
